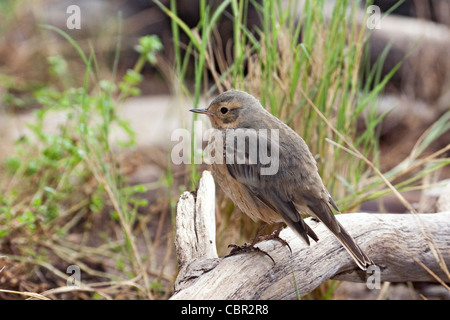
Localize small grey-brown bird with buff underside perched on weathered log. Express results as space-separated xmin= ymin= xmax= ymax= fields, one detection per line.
xmin=190 ymin=90 xmax=373 ymax=270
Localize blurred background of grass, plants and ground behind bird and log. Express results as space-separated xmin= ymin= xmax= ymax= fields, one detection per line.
xmin=0 ymin=0 xmax=450 ymax=299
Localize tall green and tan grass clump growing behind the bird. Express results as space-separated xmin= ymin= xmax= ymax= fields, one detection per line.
xmin=155 ymin=0 xmax=448 ymax=210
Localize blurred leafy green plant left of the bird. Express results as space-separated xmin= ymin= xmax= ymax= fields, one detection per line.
xmin=0 ymin=26 xmax=162 ymax=297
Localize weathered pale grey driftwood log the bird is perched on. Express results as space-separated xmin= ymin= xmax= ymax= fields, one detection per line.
xmin=171 ymin=171 xmax=450 ymax=299
